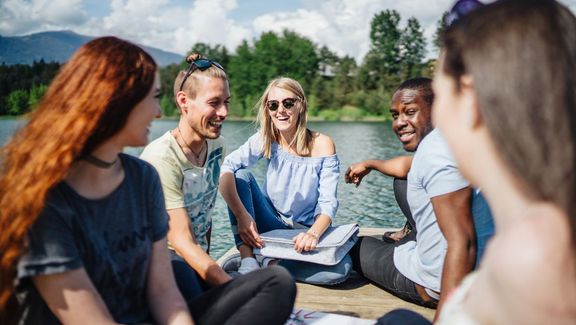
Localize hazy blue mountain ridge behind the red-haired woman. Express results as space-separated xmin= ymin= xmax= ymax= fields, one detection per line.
xmin=0 ymin=31 xmax=184 ymax=66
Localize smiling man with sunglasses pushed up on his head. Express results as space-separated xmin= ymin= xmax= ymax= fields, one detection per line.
xmin=140 ymin=53 xmax=231 ymax=298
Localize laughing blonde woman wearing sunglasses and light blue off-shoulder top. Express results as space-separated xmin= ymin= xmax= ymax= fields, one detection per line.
xmin=220 ymin=78 xmax=351 ymax=285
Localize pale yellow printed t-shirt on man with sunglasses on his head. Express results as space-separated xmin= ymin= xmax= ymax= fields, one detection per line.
xmin=140 ymin=131 xmax=225 ymax=251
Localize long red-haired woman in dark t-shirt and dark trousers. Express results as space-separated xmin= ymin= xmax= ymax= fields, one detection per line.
xmin=0 ymin=37 xmax=296 ymax=324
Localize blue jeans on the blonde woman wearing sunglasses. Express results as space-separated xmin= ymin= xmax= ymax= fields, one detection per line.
xmin=228 ymin=169 xmax=352 ymax=285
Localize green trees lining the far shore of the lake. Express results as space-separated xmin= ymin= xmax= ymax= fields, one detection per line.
xmin=0 ymin=10 xmax=445 ymax=120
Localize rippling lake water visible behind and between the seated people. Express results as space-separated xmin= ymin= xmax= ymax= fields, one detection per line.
xmin=0 ymin=120 xmax=405 ymax=258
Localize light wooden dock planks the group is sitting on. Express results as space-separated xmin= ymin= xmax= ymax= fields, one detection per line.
xmin=218 ymin=228 xmax=435 ymax=320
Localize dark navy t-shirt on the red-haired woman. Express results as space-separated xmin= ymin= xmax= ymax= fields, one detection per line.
xmin=17 ymin=154 xmax=168 ymax=324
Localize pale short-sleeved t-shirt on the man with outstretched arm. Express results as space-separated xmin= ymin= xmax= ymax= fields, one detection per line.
xmin=394 ymin=129 xmax=469 ymax=292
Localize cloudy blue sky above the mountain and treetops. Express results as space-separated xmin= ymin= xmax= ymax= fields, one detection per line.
xmin=0 ymin=0 xmax=576 ymax=62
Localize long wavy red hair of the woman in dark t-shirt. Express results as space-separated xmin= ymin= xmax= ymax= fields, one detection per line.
xmin=0 ymin=37 xmax=157 ymax=314
